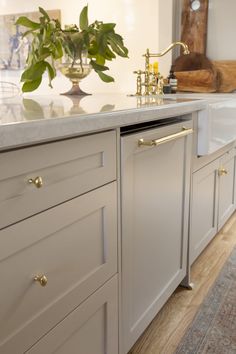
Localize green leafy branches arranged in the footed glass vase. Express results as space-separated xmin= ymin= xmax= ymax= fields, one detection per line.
xmin=16 ymin=6 xmax=128 ymax=92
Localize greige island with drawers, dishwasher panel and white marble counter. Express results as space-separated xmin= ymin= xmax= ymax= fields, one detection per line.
xmin=0 ymin=95 xmax=235 ymax=354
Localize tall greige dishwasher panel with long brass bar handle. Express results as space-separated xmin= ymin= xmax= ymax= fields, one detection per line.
xmin=121 ymin=122 xmax=192 ymax=353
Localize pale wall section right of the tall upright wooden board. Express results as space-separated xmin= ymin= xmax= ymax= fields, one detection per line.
xmin=207 ymin=0 xmax=236 ymax=60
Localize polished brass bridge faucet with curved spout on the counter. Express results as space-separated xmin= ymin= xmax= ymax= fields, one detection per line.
xmin=134 ymin=42 xmax=190 ymax=96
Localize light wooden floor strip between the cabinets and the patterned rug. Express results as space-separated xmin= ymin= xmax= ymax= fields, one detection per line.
xmin=129 ymin=213 xmax=236 ymax=354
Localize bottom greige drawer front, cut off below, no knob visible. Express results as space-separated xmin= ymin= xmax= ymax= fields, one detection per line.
xmin=26 ymin=276 xmax=118 ymax=354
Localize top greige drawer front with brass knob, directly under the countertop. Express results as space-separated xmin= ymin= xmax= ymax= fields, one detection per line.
xmin=0 ymin=131 xmax=116 ymax=229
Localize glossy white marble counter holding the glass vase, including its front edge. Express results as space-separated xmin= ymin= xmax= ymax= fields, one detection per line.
xmin=0 ymin=94 xmax=206 ymax=150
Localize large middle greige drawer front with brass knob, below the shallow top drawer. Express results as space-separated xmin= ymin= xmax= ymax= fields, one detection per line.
xmin=0 ymin=182 xmax=117 ymax=354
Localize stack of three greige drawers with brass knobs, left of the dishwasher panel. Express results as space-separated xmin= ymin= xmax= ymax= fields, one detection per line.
xmin=0 ymin=131 xmax=118 ymax=354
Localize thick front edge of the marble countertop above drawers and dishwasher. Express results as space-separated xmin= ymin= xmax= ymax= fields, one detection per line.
xmin=0 ymin=99 xmax=208 ymax=151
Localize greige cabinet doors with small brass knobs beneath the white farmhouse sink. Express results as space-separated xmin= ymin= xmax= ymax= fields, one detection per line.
xmin=190 ymin=149 xmax=235 ymax=264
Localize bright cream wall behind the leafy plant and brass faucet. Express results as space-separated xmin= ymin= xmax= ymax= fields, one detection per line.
xmin=0 ymin=0 xmax=173 ymax=94
